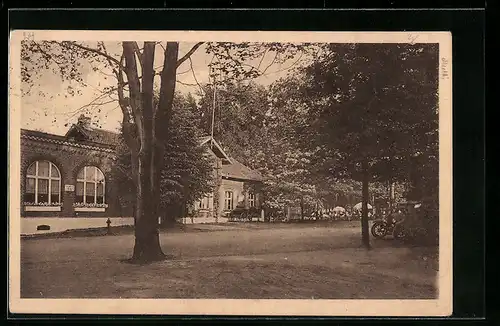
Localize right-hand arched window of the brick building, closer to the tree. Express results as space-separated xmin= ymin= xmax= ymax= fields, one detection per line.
xmin=75 ymin=166 xmax=105 ymax=204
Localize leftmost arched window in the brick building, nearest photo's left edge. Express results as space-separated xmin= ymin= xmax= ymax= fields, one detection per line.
xmin=24 ymin=161 xmax=61 ymax=204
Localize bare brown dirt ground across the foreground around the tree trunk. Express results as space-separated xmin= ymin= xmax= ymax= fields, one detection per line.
xmin=21 ymin=222 xmax=438 ymax=299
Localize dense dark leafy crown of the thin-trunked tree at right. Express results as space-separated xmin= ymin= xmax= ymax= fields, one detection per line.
xmin=275 ymin=44 xmax=438 ymax=192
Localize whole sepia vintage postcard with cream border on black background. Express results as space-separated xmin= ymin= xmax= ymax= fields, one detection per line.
xmin=8 ymin=30 xmax=453 ymax=316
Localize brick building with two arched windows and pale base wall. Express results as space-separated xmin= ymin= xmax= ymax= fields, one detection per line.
xmin=21 ymin=116 xmax=133 ymax=233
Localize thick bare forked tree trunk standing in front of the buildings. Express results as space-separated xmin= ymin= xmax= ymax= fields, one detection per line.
xmin=115 ymin=42 xmax=182 ymax=263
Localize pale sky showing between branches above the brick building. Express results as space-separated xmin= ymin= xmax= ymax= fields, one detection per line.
xmin=21 ymin=42 xmax=300 ymax=135
